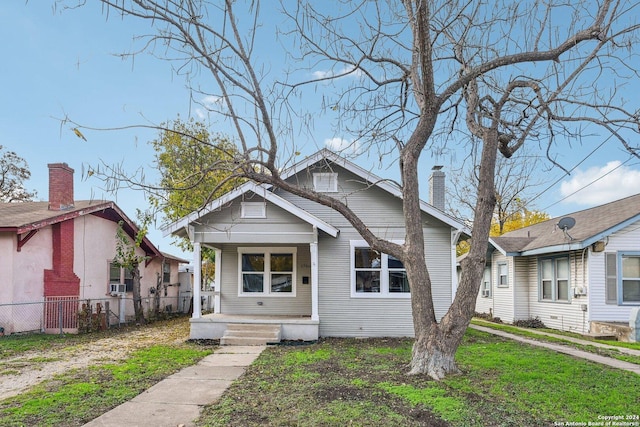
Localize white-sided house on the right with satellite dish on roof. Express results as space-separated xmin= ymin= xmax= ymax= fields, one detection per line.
xmin=476 ymin=194 xmax=640 ymax=340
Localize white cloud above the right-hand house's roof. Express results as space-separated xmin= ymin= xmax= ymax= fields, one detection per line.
xmin=560 ymin=160 xmax=640 ymax=206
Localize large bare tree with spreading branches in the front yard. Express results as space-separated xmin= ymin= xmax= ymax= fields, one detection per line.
xmin=67 ymin=0 xmax=640 ymax=378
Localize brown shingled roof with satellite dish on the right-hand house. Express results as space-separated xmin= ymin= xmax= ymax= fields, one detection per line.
xmin=493 ymin=194 xmax=640 ymax=256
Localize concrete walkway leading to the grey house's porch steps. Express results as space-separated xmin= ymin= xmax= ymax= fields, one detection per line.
xmin=85 ymin=346 xmax=265 ymax=427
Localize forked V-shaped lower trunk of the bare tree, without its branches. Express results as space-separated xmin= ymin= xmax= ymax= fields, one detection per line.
xmin=403 ymin=125 xmax=497 ymax=380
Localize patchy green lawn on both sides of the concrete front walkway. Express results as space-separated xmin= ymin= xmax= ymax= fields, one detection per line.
xmin=0 ymin=320 xmax=640 ymax=427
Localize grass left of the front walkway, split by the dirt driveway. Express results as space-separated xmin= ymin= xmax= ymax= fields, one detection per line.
xmin=0 ymin=317 xmax=213 ymax=427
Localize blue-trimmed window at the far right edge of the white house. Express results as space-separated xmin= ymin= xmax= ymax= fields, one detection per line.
xmin=605 ymin=252 xmax=640 ymax=305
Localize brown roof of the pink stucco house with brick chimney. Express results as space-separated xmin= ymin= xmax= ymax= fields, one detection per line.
xmin=0 ymin=200 xmax=161 ymax=257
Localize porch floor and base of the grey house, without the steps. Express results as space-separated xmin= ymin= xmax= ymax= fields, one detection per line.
xmin=190 ymin=313 xmax=320 ymax=341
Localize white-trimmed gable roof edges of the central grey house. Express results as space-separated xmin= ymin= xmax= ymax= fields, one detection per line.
xmin=161 ymin=149 xmax=469 ymax=237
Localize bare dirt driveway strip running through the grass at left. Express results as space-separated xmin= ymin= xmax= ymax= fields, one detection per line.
xmin=0 ymin=318 xmax=189 ymax=400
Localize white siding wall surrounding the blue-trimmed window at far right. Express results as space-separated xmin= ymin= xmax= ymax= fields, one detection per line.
xmin=588 ymin=223 xmax=640 ymax=322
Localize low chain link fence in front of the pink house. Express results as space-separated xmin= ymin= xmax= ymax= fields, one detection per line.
xmin=0 ymin=296 xmax=191 ymax=335
